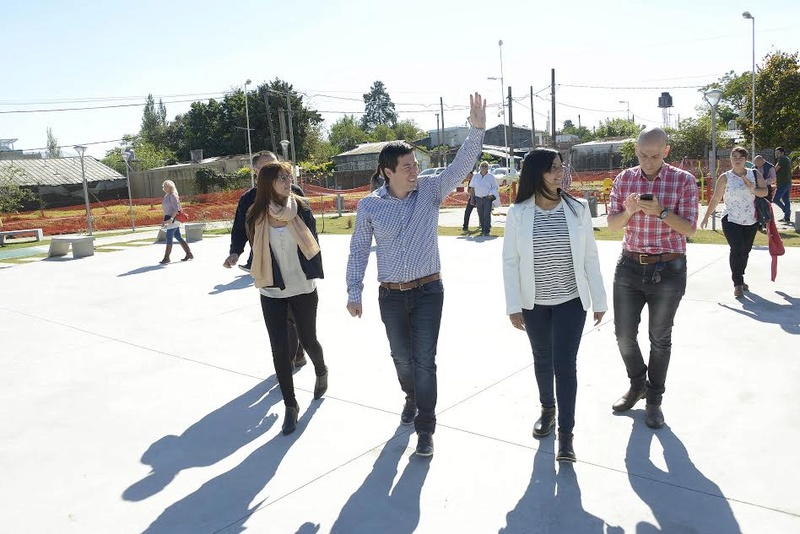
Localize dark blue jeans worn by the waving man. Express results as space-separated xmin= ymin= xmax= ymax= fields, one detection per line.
xmin=378 ymin=280 xmax=444 ymax=432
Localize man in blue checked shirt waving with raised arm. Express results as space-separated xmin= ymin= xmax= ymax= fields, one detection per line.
xmin=347 ymin=93 xmax=486 ymax=456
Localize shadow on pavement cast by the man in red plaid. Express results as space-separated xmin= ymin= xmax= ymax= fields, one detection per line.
xmin=625 ymin=410 xmax=741 ymax=533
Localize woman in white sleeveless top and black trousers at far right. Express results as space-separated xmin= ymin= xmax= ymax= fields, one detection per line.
xmin=700 ymin=146 xmax=768 ymax=298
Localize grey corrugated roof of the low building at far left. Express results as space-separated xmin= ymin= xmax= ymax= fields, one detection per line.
xmin=0 ymin=156 xmax=125 ymax=186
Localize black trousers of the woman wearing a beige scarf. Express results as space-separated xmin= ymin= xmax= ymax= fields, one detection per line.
xmin=261 ymin=289 xmax=325 ymax=406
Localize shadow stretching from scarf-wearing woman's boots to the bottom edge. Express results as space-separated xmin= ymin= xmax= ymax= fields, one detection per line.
xmin=144 ymin=402 xmax=325 ymax=534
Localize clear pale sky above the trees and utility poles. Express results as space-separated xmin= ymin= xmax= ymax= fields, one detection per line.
xmin=0 ymin=0 xmax=800 ymax=157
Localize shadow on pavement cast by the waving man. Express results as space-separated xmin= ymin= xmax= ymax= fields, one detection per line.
xmin=331 ymin=432 xmax=431 ymax=534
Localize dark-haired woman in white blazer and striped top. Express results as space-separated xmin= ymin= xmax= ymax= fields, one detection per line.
xmin=503 ymin=148 xmax=608 ymax=462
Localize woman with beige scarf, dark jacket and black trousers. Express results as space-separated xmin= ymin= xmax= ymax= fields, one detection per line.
xmin=245 ymin=162 xmax=328 ymax=434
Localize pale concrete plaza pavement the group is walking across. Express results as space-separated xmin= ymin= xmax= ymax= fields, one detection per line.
xmin=0 ymin=224 xmax=800 ymax=534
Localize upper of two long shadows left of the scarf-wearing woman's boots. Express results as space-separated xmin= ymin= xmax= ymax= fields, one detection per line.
xmin=122 ymin=379 xmax=283 ymax=501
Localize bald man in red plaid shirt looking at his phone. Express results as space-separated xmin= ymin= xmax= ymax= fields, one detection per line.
xmin=608 ymin=128 xmax=698 ymax=428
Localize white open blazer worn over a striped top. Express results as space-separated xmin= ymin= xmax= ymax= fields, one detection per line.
xmin=503 ymin=197 xmax=608 ymax=315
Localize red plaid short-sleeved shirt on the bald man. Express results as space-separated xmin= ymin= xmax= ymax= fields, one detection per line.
xmin=608 ymin=163 xmax=698 ymax=254
